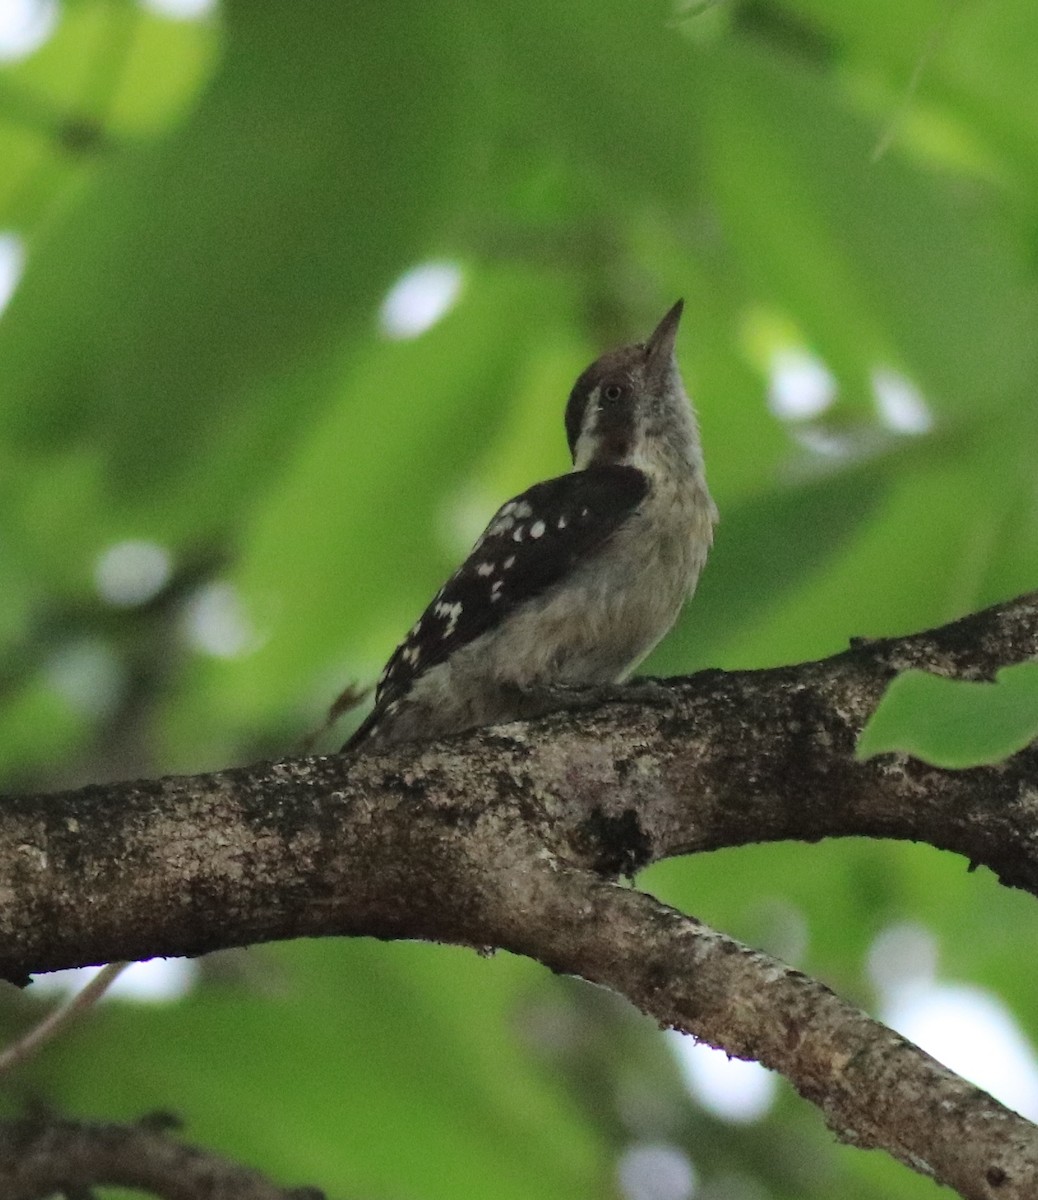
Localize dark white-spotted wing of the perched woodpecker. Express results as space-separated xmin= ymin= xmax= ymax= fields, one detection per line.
xmin=365 ymin=467 xmax=648 ymax=724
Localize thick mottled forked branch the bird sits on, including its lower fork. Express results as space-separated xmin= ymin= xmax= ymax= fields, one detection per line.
xmin=0 ymin=594 xmax=1038 ymax=1200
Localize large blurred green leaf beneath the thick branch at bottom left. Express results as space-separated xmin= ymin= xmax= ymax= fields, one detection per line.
xmin=25 ymin=938 xmax=605 ymax=1200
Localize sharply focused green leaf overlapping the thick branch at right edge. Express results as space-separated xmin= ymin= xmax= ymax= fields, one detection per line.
xmin=856 ymin=662 xmax=1038 ymax=768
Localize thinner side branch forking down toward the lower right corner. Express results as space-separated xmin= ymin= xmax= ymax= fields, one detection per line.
xmin=510 ymin=869 xmax=1038 ymax=1200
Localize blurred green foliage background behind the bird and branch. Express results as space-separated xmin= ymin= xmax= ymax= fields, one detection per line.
xmin=0 ymin=0 xmax=1038 ymax=1200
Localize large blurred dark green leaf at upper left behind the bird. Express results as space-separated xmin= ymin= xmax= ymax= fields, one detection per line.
xmin=0 ymin=2 xmax=472 ymax=538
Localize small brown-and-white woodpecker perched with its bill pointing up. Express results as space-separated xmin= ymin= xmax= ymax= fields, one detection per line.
xmin=343 ymin=300 xmax=718 ymax=751
